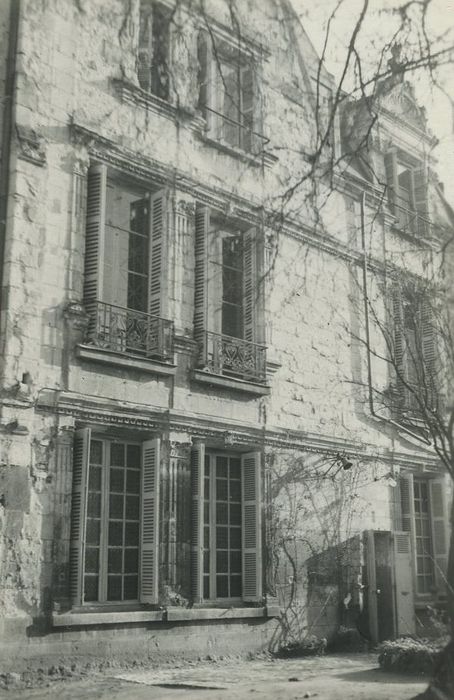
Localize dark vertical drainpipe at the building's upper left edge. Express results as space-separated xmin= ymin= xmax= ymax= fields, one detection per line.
xmin=0 ymin=0 xmax=20 ymax=348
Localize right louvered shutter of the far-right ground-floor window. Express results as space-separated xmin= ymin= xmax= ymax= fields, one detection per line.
xmin=429 ymin=478 xmax=451 ymax=594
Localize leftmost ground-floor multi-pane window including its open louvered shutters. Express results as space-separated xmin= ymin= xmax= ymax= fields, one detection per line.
xmin=70 ymin=428 xmax=159 ymax=605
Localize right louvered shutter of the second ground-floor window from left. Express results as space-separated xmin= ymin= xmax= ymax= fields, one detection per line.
xmin=241 ymin=452 xmax=262 ymax=603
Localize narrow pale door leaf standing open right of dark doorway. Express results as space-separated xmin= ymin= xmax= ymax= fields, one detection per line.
xmin=393 ymin=532 xmax=416 ymax=637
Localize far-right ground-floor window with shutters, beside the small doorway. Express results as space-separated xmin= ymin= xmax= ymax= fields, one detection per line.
xmin=399 ymin=474 xmax=449 ymax=596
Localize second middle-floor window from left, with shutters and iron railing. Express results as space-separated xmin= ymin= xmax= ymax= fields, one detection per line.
xmin=194 ymin=206 xmax=266 ymax=381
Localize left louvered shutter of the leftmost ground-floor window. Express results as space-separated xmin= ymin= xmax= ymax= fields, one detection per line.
xmin=69 ymin=428 xmax=91 ymax=605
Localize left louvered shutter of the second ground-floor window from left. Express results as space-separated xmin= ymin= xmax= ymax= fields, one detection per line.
xmin=191 ymin=443 xmax=205 ymax=603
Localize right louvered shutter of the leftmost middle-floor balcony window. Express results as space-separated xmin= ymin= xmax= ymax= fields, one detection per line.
xmin=148 ymin=190 xmax=169 ymax=316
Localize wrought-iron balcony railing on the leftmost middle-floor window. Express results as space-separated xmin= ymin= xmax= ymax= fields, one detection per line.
xmin=86 ymin=301 xmax=174 ymax=362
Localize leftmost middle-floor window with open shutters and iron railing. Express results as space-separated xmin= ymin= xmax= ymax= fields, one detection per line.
xmin=84 ymin=165 xmax=173 ymax=360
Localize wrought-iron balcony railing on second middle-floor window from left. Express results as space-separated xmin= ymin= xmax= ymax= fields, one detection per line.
xmin=197 ymin=331 xmax=266 ymax=382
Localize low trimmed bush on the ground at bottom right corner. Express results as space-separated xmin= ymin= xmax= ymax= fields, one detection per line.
xmin=378 ymin=637 xmax=449 ymax=675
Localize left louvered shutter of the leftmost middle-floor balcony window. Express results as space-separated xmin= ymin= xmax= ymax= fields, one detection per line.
xmin=84 ymin=165 xmax=107 ymax=302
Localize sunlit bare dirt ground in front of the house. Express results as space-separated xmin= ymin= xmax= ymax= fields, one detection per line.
xmin=3 ymin=654 xmax=427 ymax=700
